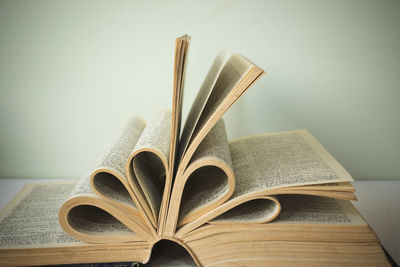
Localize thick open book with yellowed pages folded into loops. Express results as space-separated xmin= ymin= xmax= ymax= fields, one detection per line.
xmin=0 ymin=35 xmax=387 ymax=266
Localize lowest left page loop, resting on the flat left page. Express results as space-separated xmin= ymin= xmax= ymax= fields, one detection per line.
xmin=58 ymin=173 xmax=152 ymax=243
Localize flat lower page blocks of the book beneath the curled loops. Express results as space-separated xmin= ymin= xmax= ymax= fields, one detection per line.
xmin=0 ymin=181 xmax=390 ymax=266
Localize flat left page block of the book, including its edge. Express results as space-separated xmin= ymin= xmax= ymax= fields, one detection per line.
xmin=0 ymin=184 xmax=151 ymax=266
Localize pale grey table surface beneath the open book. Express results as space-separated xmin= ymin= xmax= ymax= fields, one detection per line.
xmin=0 ymin=179 xmax=400 ymax=266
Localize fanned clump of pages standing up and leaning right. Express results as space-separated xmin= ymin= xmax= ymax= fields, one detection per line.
xmin=164 ymin=54 xmax=264 ymax=236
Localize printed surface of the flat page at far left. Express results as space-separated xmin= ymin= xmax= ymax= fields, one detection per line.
xmin=0 ymin=183 xmax=80 ymax=250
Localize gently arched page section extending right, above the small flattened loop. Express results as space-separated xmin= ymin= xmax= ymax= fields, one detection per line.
xmin=177 ymin=130 xmax=354 ymax=236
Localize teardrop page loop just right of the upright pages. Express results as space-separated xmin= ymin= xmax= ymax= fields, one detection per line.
xmin=168 ymin=119 xmax=235 ymax=230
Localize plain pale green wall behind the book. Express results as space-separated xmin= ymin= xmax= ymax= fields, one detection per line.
xmin=0 ymin=0 xmax=400 ymax=179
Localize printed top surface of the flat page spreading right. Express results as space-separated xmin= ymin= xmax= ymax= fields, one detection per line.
xmin=230 ymin=130 xmax=352 ymax=199
